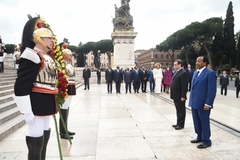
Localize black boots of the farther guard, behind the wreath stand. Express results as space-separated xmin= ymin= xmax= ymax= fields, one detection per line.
xmin=59 ymin=109 xmax=73 ymax=139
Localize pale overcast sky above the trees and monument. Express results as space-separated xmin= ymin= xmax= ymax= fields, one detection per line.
xmin=0 ymin=0 xmax=240 ymax=50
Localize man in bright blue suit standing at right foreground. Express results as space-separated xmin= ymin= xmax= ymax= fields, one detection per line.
xmin=189 ymin=56 xmax=217 ymax=148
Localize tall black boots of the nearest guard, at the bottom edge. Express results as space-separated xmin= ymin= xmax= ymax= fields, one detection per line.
xmin=26 ymin=136 xmax=44 ymax=160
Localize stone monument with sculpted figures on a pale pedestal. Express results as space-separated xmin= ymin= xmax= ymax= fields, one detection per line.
xmin=111 ymin=0 xmax=137 ymax=69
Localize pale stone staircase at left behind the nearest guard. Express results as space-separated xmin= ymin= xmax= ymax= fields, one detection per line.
xmin=0 ymin=55 xmax=82 ymax=141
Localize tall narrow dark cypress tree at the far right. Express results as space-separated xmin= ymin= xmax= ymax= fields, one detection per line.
xmin=224 ymin=1 xmax=236 ymax=67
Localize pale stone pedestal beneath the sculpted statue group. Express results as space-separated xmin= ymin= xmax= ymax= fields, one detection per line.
xmin=112 ymin=30 xmax=137 ymax=69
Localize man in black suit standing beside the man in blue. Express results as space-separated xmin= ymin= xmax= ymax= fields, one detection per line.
xmin=170 ymin=59 xmax=188 ymax=130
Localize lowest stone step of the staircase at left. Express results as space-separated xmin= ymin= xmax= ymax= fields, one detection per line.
xmin=0 ymin=115 xmax=26 ymax=141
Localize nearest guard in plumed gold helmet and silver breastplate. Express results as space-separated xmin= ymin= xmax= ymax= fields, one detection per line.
xmin=14 ymin=17 xmax=58 ymax=160
